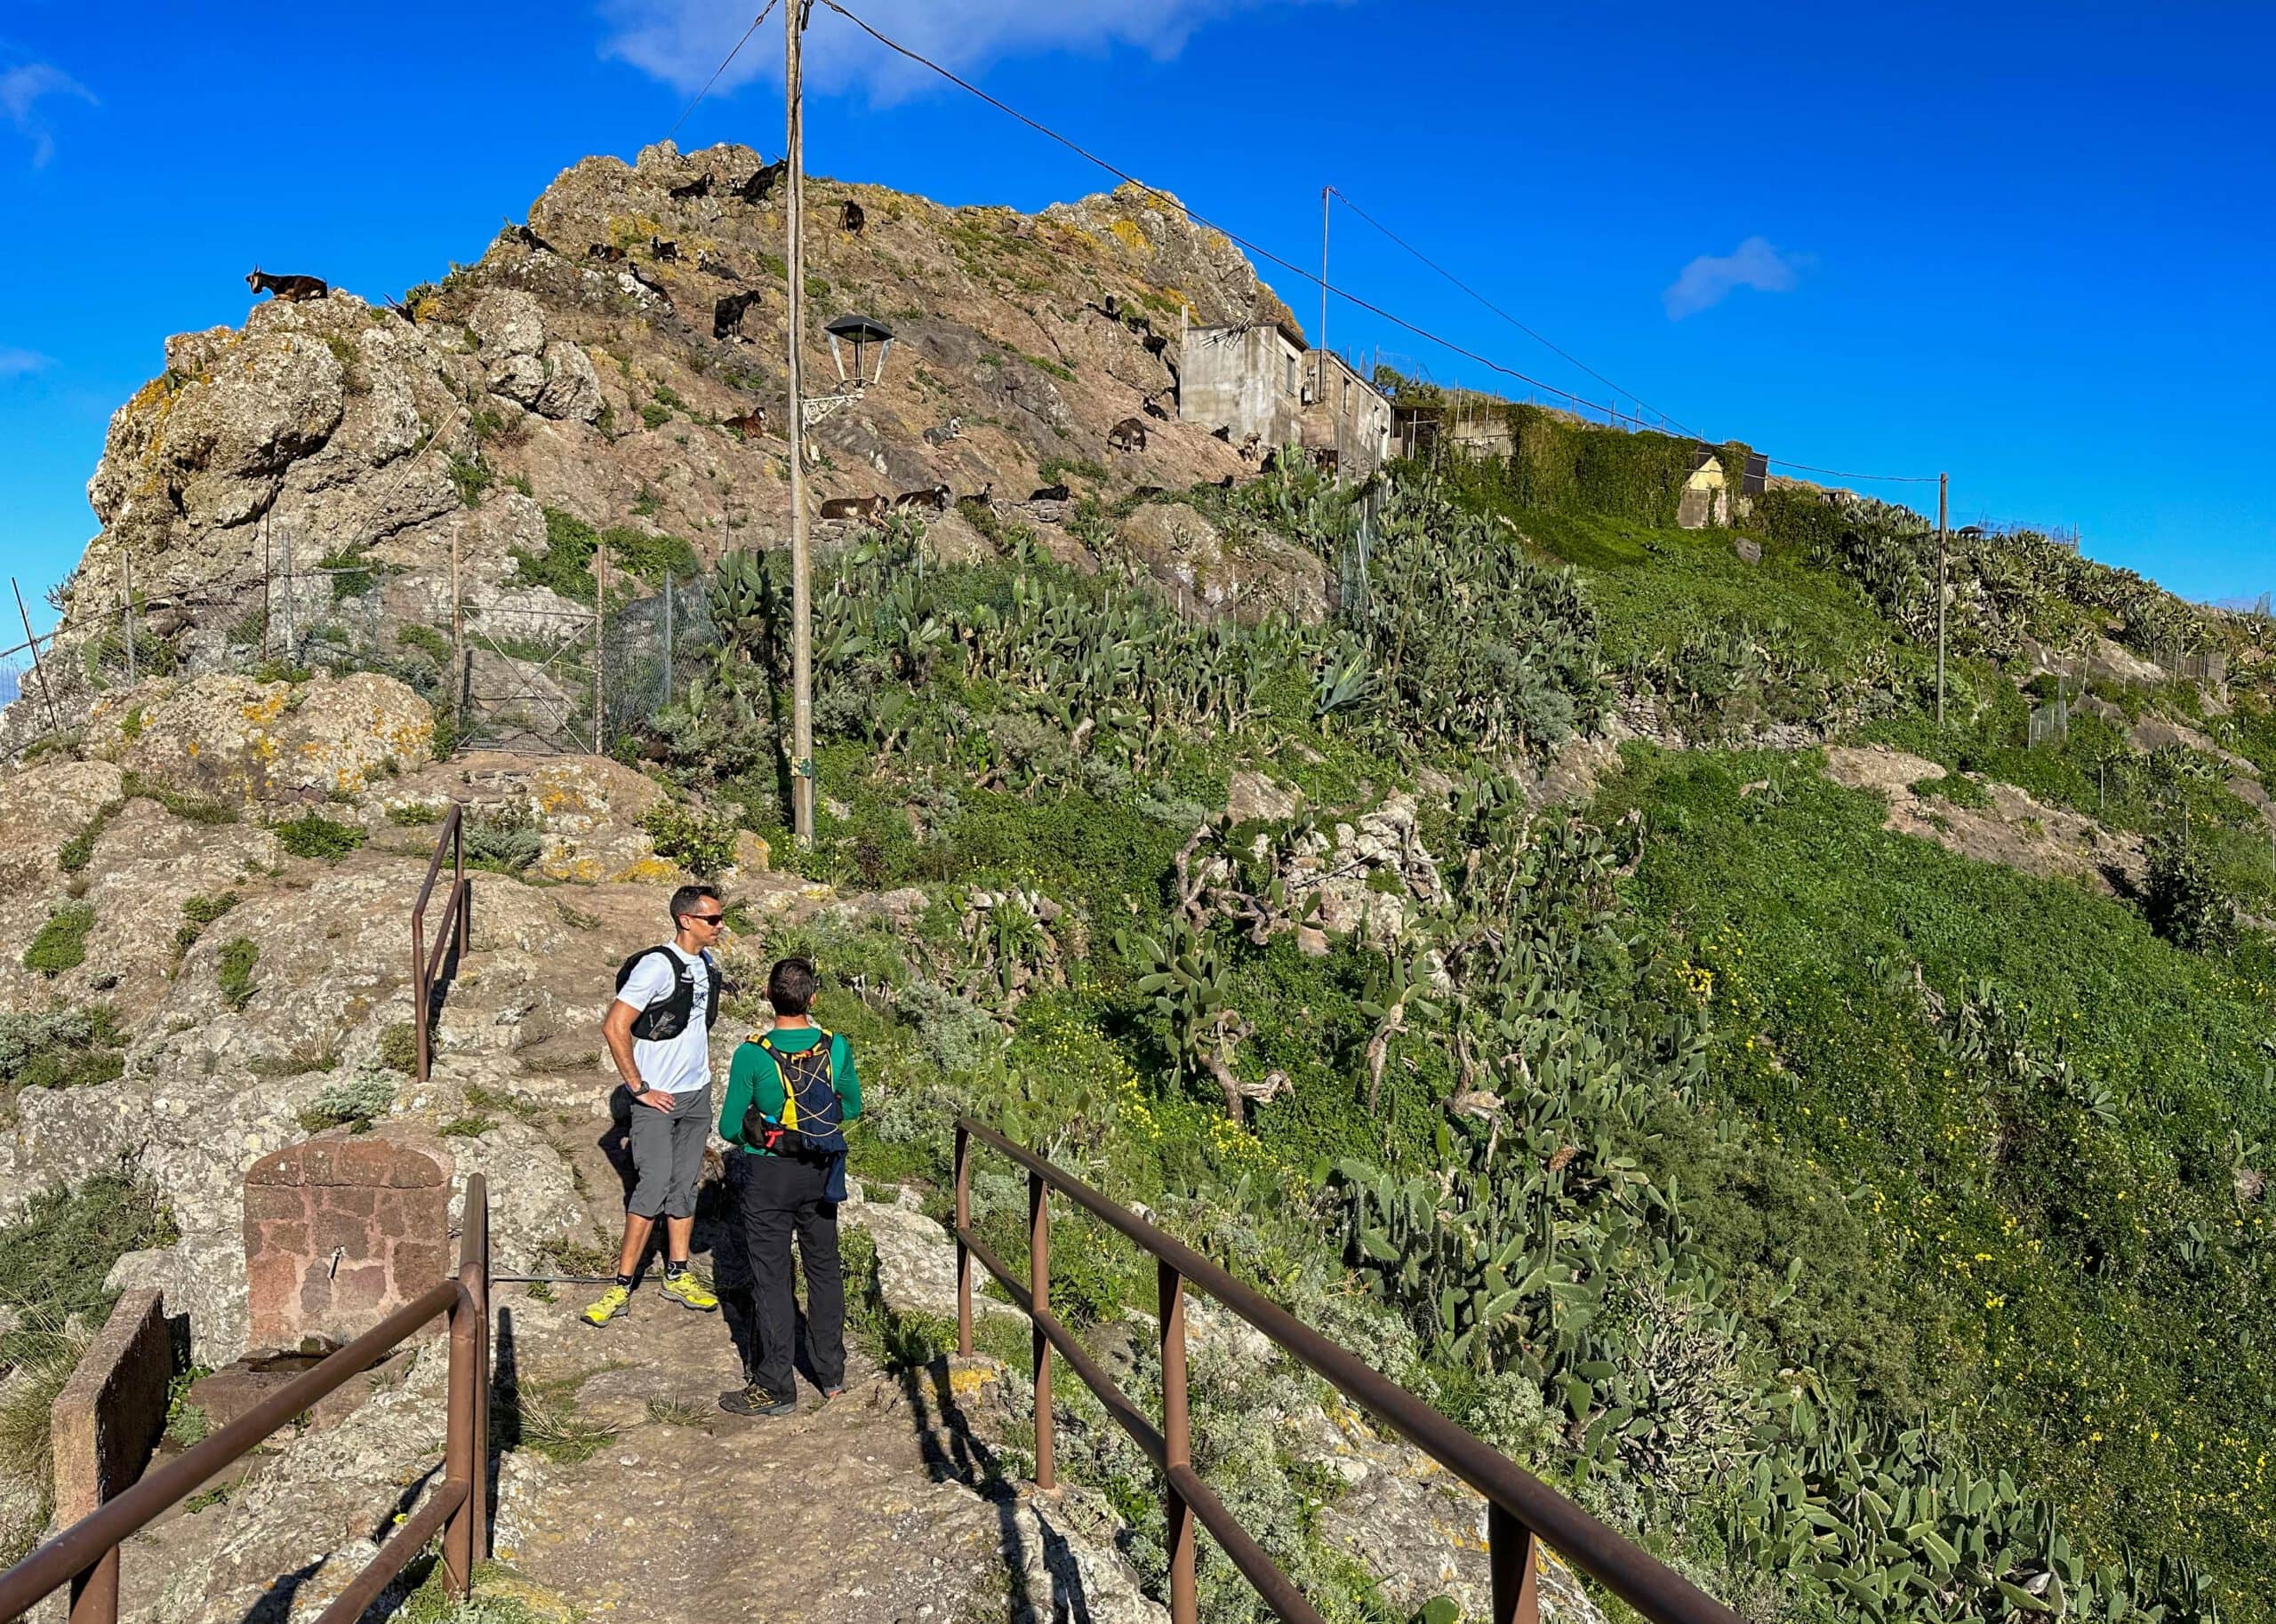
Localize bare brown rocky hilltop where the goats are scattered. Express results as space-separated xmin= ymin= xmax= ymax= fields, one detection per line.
xmin=40 ymin=143 xmax=1293 ymax=732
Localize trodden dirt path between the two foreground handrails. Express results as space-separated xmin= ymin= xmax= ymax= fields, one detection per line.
xmin=496 ymin=1237 xmax=1158 ymax=1624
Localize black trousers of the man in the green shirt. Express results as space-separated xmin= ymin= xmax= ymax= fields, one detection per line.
xmin=742 ymin=1156 xmax=846 ymax=1399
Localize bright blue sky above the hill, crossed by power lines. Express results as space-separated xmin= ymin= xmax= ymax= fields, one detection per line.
xmin=0 ymin=0 xmax=2276 ymax=642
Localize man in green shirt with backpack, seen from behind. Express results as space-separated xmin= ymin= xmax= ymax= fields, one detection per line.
xmin=719 ymin=957 xmax=861 ymax=1415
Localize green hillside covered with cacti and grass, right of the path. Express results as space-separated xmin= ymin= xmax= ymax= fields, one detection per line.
xmin=632 ymin=428 xmax=2276 ymax=1620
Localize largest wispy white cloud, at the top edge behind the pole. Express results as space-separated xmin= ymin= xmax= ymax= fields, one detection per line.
xmin=601 ymin=0 xmax=1310 ymax=102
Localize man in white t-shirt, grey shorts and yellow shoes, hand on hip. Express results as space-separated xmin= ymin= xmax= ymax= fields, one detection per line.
xmin=585 ymin=884 xmax=726 ymax=1326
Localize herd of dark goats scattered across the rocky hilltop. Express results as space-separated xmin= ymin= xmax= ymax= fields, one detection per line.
xmin=245 ymin=159 xmax=1302 ymax=524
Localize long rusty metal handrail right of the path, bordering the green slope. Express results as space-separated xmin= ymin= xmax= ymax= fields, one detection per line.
xmin=956 ymin=1116 xmax=1739 ymax=1624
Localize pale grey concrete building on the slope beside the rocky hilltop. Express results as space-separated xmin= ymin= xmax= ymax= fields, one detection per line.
xmin=1177 ymin=321 xmax=1390 ymax=476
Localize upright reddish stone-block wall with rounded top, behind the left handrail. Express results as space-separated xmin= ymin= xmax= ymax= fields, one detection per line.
xmin=245 ymin=1126 xmax=451 ymax=1348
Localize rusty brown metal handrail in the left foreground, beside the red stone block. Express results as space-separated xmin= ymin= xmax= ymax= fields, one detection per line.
xmin=0 ymin=1173 xmax=489 ymax=1624
